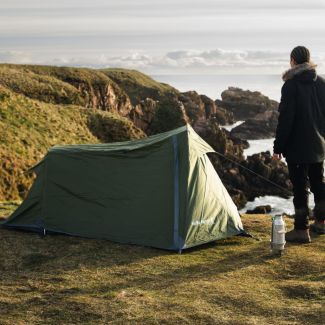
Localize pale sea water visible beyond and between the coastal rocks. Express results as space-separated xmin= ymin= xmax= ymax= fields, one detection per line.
xmin=151 ymin=74 xmax=314 ymax=215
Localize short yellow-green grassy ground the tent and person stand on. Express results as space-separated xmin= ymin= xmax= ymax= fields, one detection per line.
xmin=0 ymin=203 xmax=325 ymax=325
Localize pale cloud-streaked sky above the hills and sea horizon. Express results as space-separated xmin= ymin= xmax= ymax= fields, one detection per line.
xmin=0 ymin=0 xmax=325 ymax=75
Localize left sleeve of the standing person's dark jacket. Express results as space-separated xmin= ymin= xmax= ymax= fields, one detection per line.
xmin=273 ymin=80 xmax=296 ymax=154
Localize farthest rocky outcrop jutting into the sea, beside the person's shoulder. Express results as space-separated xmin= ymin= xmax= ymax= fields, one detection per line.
xmin=216 ymin=87 xmax=278 ymax=121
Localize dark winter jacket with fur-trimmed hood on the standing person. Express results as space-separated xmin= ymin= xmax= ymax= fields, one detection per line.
xmin=273 ymin=63 xmax=325 ymax=163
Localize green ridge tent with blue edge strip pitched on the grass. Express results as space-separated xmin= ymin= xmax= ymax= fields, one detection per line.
xmin=5 ymin=125 xmax=243 ymax=250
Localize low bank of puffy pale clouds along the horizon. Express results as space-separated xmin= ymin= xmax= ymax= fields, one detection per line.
xmin=0 ymin=48 xmax=325 ymax=74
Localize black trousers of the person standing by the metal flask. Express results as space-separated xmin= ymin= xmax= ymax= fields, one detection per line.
xmin=288 ymin=162 xmax=325 ymax=229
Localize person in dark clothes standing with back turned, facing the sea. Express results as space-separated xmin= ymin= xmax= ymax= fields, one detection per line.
xmin=273 ymin=46 xmax=325 ymax=243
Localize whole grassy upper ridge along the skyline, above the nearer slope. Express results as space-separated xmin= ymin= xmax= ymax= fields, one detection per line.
xmin=0 ymin=64 xmax=179 ymax=108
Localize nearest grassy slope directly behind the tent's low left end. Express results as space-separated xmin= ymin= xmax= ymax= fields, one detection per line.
xmin=0 ymin=86 xmax=145 ymax=200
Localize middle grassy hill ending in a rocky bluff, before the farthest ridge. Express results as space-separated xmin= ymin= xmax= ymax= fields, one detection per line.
xmin=0 ymin=64 xmax=131 ymax=110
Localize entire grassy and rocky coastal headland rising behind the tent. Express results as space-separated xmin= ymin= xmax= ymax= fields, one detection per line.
xmin=0 ymin=64 xmax=288 ymax=206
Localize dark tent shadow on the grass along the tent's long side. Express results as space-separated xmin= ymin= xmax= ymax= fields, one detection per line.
xmin=0 ymin=228 xmax=170 ymax=276
